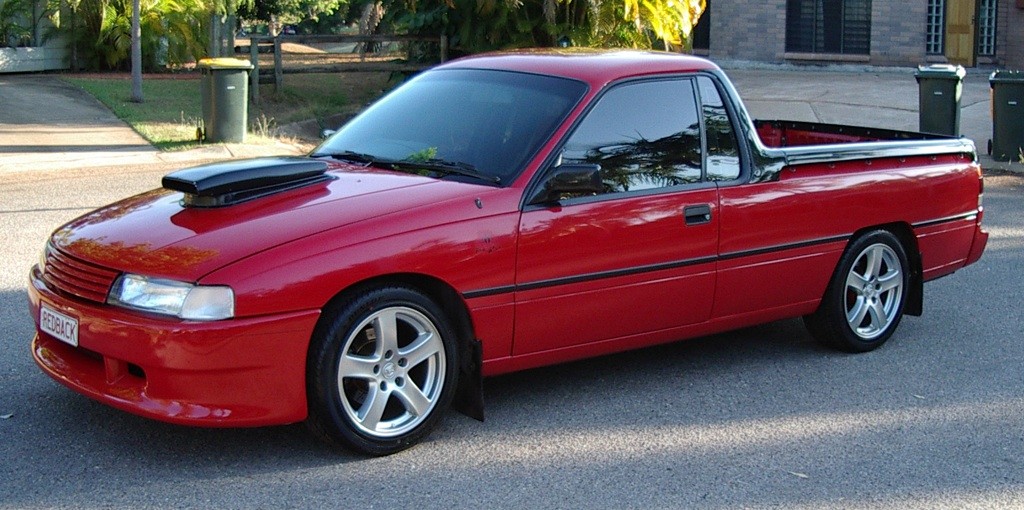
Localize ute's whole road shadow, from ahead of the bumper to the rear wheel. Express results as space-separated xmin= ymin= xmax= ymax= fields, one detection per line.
xmin=0 ymin=282 xmax=822 ymax=473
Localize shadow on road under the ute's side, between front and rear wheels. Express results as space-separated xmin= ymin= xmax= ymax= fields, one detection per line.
xmin=485 ymin=320 xmax=847 ymax=426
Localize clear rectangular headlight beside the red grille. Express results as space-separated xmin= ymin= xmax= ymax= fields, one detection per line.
xmin=106 ymin=273 xmax=234 ymax=321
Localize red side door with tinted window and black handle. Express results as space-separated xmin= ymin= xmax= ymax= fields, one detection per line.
xmin=513 ymin=77 xmax=719 ymax=355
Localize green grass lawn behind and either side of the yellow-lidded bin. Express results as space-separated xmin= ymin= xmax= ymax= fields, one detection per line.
xmin=63 ymin=73 xmax=393 ymax=151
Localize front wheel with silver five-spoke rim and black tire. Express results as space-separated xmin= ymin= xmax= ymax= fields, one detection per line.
xmin=307 ymin=287 xmax=459 ymax=456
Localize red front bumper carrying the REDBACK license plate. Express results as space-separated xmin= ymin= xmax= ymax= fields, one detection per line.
xmin=29 ymin=267 xmax=319 ymax=427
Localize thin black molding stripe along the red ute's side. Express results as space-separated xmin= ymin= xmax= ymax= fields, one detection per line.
xmin=462 ymin=211 xmax=978 ymax=299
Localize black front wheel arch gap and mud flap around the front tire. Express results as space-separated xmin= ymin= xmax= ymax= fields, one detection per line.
xmin=314 ymin=272 xmax=483 ymax=421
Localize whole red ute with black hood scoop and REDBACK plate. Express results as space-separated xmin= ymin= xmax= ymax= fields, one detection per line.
xmin=29 ymin=51 xmax=987 ymax=455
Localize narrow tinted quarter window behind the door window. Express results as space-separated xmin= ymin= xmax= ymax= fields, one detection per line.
xmin=697 ymin=76 xmax=739 ymax=180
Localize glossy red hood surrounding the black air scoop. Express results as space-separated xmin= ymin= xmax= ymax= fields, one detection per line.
xmin=51 ymin=167 xmax=481 ymax=282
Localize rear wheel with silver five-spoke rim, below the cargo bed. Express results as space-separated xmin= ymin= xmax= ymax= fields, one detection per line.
xmin=804 ymin=230 xmax=910 ymax=352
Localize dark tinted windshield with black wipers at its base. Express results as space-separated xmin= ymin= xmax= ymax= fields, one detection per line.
xmin=313 ymin=70 xmax=587 ymax=184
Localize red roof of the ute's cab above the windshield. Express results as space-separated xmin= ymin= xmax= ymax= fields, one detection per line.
xmin=435 ymin=48 xmax=719 ymax=86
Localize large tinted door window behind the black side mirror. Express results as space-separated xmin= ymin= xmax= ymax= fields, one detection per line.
xmin=562 ymin=79 xmax=701 ymax=193
